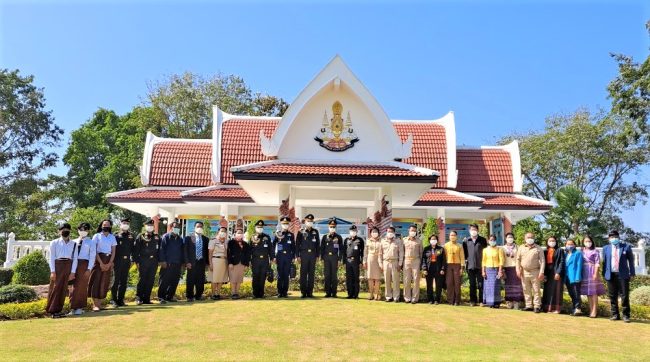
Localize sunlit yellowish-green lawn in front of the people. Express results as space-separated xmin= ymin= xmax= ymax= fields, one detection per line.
xmin=0 ymin=292 xmax=650 ymax=361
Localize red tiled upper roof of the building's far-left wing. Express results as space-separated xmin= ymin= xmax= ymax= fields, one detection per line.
xmin=149 ymin=140 xmax=213 ymax=186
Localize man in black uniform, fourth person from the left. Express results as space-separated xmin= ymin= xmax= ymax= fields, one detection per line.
xmin=111 ymin=217 xmax=135 ymax=307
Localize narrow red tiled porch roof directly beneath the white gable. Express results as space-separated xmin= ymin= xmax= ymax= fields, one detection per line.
xmin=235 ymin=163 xmax=435 ymax=180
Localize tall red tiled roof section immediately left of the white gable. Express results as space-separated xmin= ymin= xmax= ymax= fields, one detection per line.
xmin=221 ymin=118 xmax=279 ymax=184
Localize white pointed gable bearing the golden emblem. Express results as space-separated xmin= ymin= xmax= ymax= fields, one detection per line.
xmin=260 ymin=56 xmax=411 ymax=162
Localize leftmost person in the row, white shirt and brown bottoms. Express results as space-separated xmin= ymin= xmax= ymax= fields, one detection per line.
xmin=45 ymin=223 xmax=77 ymax=318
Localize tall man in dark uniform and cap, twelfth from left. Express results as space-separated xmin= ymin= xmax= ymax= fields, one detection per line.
xmin=297 ymin=214 xmax=320 ymax=298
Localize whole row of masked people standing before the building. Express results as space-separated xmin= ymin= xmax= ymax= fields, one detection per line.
xmin=46 ymin=214 xmax=634 ymax=322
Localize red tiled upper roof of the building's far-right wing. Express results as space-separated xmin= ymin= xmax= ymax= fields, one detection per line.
xmin=456 ymin=149 xmax=514 ymax=193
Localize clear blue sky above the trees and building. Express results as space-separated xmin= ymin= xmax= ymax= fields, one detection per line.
xmin=0 ymin=1 xmax=650 ymax=230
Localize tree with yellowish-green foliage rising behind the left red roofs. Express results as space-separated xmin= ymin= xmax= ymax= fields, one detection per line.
xmin=145 ymin=72 xmax=288 ymax=138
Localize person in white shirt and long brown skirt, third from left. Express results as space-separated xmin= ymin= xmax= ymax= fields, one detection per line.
xmin=88 ymin=219 xmax=117 ymax=312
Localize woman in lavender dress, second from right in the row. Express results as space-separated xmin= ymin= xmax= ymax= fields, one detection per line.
xmin=578 ymin=235 xmax=605 ymax=318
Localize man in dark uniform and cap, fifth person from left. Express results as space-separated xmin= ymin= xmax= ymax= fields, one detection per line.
xmin=133 ymin=219 xmax=160 ymax=305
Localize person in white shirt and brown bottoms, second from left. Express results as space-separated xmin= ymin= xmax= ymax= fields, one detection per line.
xmin=70 ymin=222 xmax=97 ymax=315
